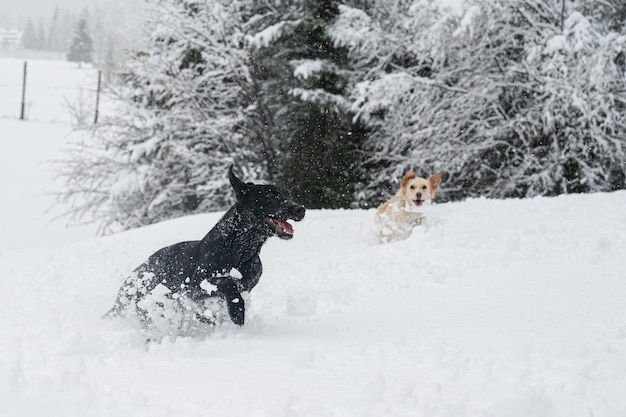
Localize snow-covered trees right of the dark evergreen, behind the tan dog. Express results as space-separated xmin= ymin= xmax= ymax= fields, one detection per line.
xmin=340 ymin=0 xmax=626 ymax=202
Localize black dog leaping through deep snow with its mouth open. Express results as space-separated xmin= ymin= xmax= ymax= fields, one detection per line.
xmin=105 ymin=165 xmax=305 ymax=326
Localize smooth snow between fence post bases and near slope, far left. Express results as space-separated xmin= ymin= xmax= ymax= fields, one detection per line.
xmin=0 ymin=117 xmax=96 ymax=249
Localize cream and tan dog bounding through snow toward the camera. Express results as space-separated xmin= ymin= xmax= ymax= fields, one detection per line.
xmin=376 ymin=171 xmax=441 ymax=242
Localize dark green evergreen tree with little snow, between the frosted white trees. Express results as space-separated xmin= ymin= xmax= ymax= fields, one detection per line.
xmin=245 ymin=0 xmax=367 ymax=208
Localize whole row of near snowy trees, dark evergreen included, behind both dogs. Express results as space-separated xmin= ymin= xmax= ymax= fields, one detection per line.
xmin=62 ymin=0 xmax=626 ymax=230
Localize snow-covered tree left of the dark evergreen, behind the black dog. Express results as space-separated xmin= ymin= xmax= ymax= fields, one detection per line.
xmin=56 ymin=0 xmax=258 ymax=229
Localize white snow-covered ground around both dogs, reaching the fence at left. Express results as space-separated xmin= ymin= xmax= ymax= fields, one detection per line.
xmin=0 ymin=60 xmax=626 ymax=417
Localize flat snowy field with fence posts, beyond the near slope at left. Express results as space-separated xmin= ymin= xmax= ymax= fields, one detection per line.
xmin=0 ymin=58 xmax=106 ymax=250
